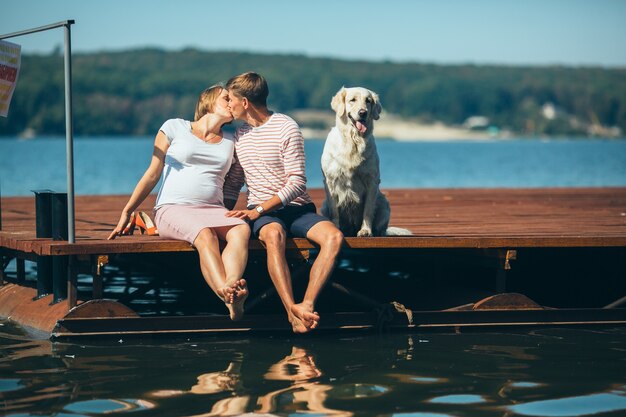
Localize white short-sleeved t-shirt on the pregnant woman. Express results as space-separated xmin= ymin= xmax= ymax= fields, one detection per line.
xmin=155 ymin=119 xmax=235 ymax=208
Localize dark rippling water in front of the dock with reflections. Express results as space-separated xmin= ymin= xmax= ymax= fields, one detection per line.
xmin=0 ymin=323 xmax=626 ymax=417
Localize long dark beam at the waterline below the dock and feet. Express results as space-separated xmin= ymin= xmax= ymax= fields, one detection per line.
xmin=52 ymin=309 xmax=626 ymax=338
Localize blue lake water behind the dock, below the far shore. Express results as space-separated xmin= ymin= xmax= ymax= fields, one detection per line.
xmin=0 ymin=137 xmax=626 ymax=196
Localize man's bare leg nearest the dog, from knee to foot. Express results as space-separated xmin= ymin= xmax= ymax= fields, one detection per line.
xmin=291 ymin=221 xmax=343 ymax=329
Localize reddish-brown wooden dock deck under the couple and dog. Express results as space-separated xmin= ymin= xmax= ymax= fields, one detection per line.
xmin=0 ymin=188 xmax=626 ymax=255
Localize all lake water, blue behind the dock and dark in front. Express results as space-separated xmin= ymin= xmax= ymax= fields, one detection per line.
xmin=0 ymin=138 xmax=626 ymax=417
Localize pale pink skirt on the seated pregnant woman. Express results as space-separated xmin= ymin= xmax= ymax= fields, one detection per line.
xmin=154 ymin=204 xmax=245 ymax=245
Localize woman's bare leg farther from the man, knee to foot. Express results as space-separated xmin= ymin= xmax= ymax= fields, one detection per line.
xmin=193 ymin=227 xmax=239 ymax=320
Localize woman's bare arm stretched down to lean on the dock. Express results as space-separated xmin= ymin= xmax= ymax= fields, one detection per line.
xmin=108 ymin=131 xmax=170 ymax=240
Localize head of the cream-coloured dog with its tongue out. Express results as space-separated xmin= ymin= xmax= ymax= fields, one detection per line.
xmin=330 ymin=87 xmax=382 ymax=136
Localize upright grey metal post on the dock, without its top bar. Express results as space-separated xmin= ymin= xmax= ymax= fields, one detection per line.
xmin=64 ymin=21 xmax=76 ymax=243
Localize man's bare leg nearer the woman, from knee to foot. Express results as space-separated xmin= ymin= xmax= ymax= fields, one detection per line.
xmin=259 ymin=223 xmax=308 ymax=333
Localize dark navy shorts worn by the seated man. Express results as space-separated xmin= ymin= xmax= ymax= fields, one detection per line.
xmin=250 ymin=203 xmax=328 ymax=238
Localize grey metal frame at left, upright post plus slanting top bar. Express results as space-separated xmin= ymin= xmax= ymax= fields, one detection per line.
xmin=0 ymin=20 xmax=76 ymax=243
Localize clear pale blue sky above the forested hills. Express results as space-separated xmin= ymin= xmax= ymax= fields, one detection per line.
xmin=0 ymin=0 xmax=626 ymax=68
